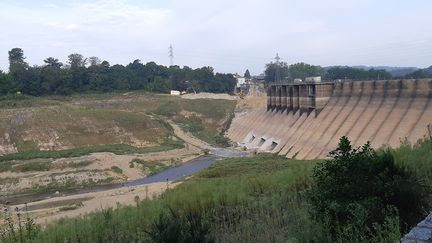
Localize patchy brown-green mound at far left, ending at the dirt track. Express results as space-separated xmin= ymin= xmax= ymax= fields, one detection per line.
xmin=0 ymin=95 xmax=169 ymax=152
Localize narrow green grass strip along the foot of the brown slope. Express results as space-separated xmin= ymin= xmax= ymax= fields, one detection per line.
xmin=0 ymin=141 xmax=183 ymax=163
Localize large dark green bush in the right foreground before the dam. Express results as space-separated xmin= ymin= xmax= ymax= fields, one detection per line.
xmin=309 ymin=137 xmax=430 ymax=241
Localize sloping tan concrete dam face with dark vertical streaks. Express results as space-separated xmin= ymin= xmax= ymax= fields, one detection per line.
xmin=227 ymin=79 xmax=432 ymax=159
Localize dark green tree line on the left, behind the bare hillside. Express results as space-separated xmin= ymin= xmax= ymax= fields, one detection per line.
xmin=0 ymin=48 xmax=236 ymax=96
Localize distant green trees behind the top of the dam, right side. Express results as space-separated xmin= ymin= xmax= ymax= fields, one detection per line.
xmin=264 ymin=62 xmax=432 ymax=83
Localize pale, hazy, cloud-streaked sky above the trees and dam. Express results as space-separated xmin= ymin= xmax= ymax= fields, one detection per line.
xmin=0 ymin=0 xmax=432 ymax=74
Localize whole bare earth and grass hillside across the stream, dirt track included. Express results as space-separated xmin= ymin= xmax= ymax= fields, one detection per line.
xmin=0 ymin=93 xmax=236 ymax=197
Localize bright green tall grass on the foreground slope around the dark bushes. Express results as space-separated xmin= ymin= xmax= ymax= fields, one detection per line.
xmin=14 ymin=141 xmax=432 ymax=242
